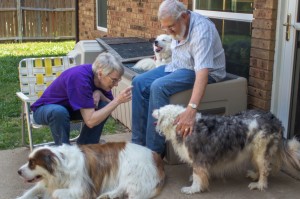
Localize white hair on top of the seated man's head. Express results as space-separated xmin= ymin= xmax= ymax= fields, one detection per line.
xmin=157 ymin=0 xmax=187 ymax=20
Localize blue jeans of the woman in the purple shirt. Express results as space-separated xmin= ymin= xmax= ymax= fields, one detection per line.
xmin=33 ymin=101 xmax=107 ymax=145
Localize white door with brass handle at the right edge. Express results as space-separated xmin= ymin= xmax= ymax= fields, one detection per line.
xmin=271 ymin=0 xmax=300 ymax=138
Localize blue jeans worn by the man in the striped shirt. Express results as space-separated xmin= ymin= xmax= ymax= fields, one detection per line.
xmin=132 ymin=66 xmax=215 ymax=154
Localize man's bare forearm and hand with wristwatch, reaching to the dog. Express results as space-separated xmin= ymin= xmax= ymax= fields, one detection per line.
xmin=175 ymin=68 xmax=208 ymax=137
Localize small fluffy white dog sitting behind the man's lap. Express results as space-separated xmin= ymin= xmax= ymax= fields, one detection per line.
xmin=132 ymin=34 xmax=172 ymax=71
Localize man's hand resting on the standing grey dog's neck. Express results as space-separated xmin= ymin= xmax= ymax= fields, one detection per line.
xmin=174 ymin=107 xmax=197 ymax=138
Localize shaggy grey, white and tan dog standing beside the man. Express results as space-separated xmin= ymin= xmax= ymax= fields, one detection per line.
xmin=152 ymin=105 xmax=300 ymax=194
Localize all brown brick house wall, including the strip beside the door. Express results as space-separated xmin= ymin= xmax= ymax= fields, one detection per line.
xmin=79 ymin=0 xmax=278 ymax=110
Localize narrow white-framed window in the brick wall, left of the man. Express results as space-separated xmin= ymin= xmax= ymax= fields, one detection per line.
xmin=96 ymin=0 xmax=107 ymax=31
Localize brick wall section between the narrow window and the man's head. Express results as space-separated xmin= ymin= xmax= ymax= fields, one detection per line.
xmin=108 ymin=0 xmax=188 ymax=38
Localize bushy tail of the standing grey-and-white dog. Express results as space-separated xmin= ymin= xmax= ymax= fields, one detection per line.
xmin=281 ymin=138 xmax=300 ymax=179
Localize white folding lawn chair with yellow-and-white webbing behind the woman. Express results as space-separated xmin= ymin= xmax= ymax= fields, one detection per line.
xmin=16 ymin=56 xmax=82 ymax=151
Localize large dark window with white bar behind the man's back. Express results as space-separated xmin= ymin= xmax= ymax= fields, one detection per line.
xmin=194 ymin=0 xmax=253 ymax=78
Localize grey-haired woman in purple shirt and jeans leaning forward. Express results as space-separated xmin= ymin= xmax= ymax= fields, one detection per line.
xmin=31 ymin=53 xmax=131 ymax=145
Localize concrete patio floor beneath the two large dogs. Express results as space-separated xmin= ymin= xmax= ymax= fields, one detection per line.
xmin=0 ymin=133 xmax=300 ymax=199
